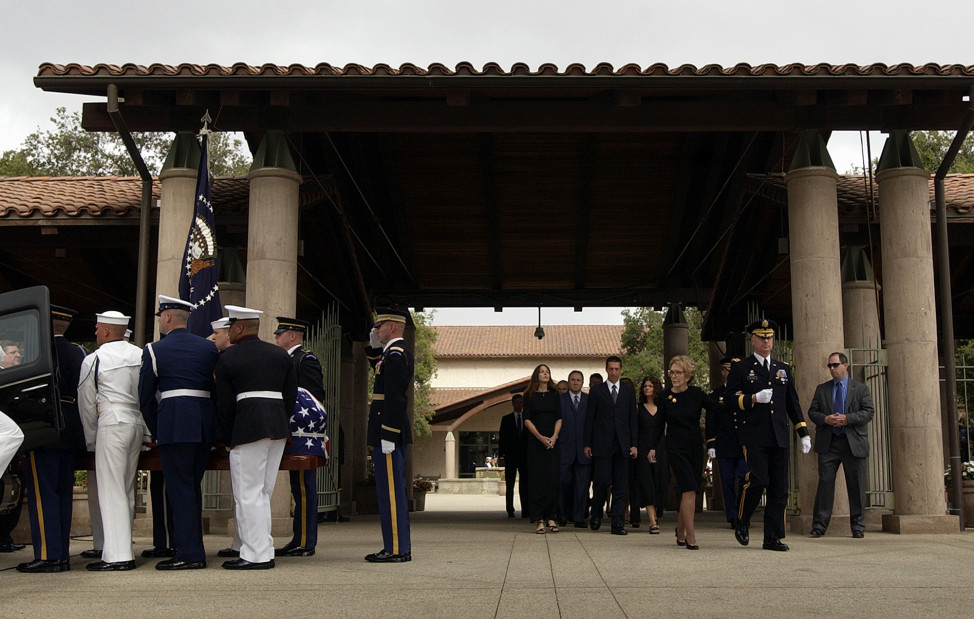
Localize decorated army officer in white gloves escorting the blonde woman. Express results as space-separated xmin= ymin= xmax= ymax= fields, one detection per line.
xmin=727 ymin=320 xmax=812 ymax=551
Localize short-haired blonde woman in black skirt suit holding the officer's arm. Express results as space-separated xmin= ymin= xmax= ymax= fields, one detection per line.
xmin=649 ymin=355 xmax=717 ymax=550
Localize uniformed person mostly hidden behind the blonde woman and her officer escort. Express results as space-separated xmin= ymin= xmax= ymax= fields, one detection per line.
xmin=705 ymin=357 xmax=747 ymax=528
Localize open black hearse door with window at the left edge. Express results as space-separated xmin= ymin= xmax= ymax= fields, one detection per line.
xmin=0 ymin=286 xmax=64 ymax=451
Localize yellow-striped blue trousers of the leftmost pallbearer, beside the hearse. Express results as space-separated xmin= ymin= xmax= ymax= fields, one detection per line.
xmin=26 ymin=448 xmax=75 ymax=561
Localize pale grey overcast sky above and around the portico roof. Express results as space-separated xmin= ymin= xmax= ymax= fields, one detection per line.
xmin=0 ymin=0 xmax=974 ymax=324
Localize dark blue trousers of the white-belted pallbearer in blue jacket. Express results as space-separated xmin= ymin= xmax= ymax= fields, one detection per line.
xmin=159 ymin=443 xmax=210 ymax=562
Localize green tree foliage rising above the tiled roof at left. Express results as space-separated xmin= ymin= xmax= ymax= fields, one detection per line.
xmin=0 ymin=107 xmax=250 ymax=176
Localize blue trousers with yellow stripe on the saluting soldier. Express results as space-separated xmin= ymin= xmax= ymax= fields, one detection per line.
xmin=372 ymin=445 xmax=412 ymax=554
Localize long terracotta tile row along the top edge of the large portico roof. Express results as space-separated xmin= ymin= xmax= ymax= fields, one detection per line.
xmin=37 ymin=62 xmax=974 ymax=77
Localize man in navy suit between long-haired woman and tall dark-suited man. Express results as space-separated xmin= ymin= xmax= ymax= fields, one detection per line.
xmin=559 ymin=370 xmax=592 ymax=529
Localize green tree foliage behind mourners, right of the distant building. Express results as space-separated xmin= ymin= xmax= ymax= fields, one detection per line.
xmin=622 ymin=307 xmax=710 ymax=391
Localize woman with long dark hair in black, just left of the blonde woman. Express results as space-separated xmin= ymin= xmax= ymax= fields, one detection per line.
xmin=629 ymin=376 xmax=670 ymax=535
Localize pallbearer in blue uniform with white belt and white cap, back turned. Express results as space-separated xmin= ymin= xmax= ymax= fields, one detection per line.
xmin=139 ymin=295 xmax=220 ymax=570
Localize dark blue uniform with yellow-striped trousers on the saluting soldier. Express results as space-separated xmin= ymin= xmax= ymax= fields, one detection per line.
xmin=366 ymin=338 xmax=413 ymax=555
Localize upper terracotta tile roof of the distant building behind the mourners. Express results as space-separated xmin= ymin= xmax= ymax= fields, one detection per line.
xmin=433 ymin=325 xmax=623 ymax=359
